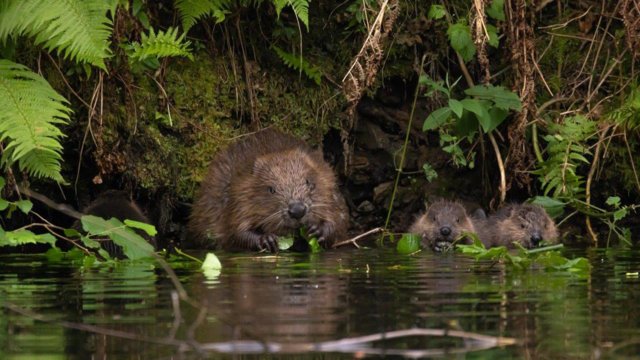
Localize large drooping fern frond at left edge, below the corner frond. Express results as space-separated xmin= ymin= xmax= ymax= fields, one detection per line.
xmin=0 ymin=59 xmax=71 ymax=182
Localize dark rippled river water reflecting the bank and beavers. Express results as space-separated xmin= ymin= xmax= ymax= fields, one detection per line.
xmin=0 ymin=249 xmax=640 ymax=359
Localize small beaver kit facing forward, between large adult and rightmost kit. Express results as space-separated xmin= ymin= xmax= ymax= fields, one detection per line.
xmin=409 ymin=200 xmax=475 ymax=252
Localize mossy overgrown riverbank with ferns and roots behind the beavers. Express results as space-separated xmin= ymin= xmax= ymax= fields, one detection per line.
xmin=0 ymin=0 xmax=640 ymax=258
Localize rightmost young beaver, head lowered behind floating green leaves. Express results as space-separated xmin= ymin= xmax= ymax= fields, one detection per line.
xmin=472 ymin=204 xmax=558 ymax=249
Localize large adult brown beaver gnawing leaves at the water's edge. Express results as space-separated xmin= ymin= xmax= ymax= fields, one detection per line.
xmin=187 ymin=129 xmax=349 ymax=252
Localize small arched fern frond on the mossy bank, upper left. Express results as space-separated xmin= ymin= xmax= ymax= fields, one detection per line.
xmin=130 ymin=28 xmax=193 ymax=61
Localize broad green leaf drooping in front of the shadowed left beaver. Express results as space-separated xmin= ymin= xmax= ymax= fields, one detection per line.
xmin=80 ymin=215 xmax=153 ymax=260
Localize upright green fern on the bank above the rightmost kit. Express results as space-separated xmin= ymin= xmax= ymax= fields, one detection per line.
xmin=533 ymin=115 xmax=596 ymax=199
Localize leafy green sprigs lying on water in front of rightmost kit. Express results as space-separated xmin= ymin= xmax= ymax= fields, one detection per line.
xmin=457 ymin=234 xmax=591 ymax=273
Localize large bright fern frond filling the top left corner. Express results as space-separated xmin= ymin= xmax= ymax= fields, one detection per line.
xmin=0 ymin=0 xmax=115 ymax=69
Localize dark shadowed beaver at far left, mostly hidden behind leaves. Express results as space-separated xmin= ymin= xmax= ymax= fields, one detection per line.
xmin=79 ymin=190 xmax=156 ymax=258
